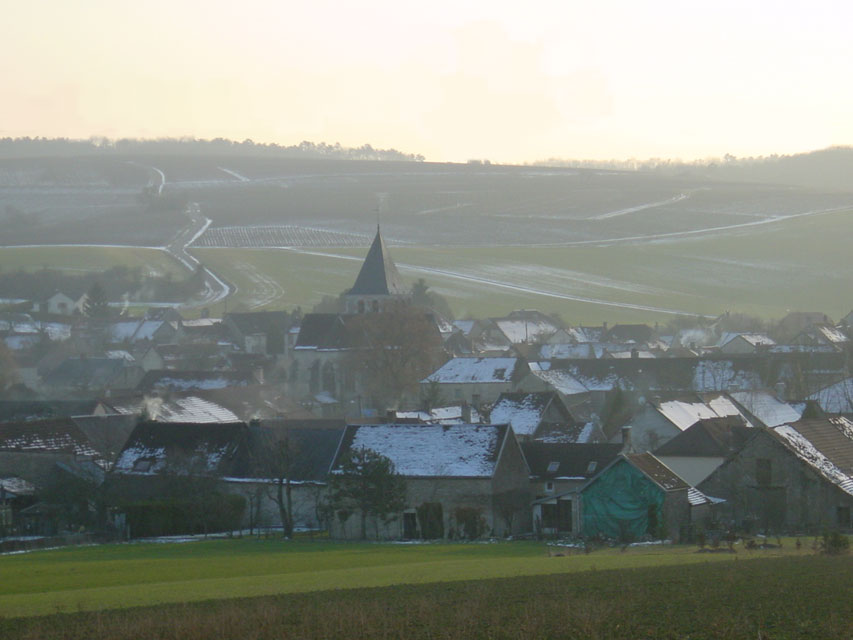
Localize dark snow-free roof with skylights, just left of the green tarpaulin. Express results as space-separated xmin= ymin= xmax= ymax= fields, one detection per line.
xmin=521 ymin=442 xmax=622 ymax=479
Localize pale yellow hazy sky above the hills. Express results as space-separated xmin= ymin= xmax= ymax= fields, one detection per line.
xmin=0 ymin=0 xmax=853 ymax=162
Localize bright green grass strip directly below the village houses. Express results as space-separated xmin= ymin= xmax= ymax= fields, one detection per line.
xmin=0 ymin=539 xmax=820 ymax=617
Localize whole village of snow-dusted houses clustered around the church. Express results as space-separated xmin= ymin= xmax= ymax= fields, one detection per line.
xmin=0 ymin=227 xmax=853 ymax=550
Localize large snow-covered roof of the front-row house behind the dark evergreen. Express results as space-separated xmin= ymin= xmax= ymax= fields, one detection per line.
xmin=342 ymin=424 xmax=507 ymax=478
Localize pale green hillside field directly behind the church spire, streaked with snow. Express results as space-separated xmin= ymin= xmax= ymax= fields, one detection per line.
xmin=194 ymin=206 xmax=853 ymax=324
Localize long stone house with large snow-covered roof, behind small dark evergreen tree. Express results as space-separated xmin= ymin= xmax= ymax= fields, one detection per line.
xmin=332 ymin=424 xmax=532 ymax=539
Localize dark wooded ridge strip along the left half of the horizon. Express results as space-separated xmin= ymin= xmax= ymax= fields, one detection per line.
xmin=0 ymin=138 xmax=424 ymax=162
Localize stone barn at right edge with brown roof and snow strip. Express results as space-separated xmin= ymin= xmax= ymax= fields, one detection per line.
xmin=699 ymin=418 xmax=853 ymax=533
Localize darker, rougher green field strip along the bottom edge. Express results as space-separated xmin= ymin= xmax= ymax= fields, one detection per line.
xmin=0 ymin=556 xmax=853 ymax=640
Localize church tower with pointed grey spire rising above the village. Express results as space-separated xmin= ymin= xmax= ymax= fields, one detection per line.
xmin=343 ymin=225 xmax=412 ymax=313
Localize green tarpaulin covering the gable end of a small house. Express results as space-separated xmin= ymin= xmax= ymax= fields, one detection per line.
xmin=581 ymin=460 xmax=665 ymax=540
